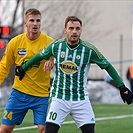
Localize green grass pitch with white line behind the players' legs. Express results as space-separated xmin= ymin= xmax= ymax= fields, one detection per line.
xmin=0 ymin=104 xmax=133 ymax=133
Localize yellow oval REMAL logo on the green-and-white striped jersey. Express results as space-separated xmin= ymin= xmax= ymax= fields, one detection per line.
xmin=59 ymin=61 xmax=78 ymax=74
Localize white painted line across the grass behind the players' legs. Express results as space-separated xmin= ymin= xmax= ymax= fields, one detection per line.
xmin=14 ymin=114 xmax=133 ymax=131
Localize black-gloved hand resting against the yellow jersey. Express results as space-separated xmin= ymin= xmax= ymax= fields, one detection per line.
xmin=15 ymin=66 xmax=25 ymax=80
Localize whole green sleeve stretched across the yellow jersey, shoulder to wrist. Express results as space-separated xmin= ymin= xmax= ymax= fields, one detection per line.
xmin=22 ymin=43 xmax=53 ymax=71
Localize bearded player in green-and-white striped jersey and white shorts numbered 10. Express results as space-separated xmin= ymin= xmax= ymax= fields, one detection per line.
xmin=14 ymin=16 xmax=132 ymax=133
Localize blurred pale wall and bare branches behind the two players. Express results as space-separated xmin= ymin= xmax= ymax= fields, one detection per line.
xmin=0 ymin=0 xmax=133 ymax=104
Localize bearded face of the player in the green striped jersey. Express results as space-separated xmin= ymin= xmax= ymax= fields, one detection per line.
xmin=64 ymin=21 xmax=82 ymax=44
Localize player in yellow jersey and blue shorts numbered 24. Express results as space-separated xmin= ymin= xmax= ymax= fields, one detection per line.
xmin=0 ymin=8 xmax=54 ymax=133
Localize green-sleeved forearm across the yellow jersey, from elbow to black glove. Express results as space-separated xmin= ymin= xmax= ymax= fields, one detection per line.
xmin=22 ymin=53 xmax=43 ymax=71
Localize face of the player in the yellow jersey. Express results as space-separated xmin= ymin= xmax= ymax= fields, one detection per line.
xmin=24 ymin=15 xmax=41 ymax=34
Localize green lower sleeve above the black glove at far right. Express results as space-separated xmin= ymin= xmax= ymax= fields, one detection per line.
xmin=105 ymin=63 xmax=124 ymax=87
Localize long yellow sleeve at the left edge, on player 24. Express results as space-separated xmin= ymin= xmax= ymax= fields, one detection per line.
xmin=0 ymin=40 xmax=15 ymax=85
